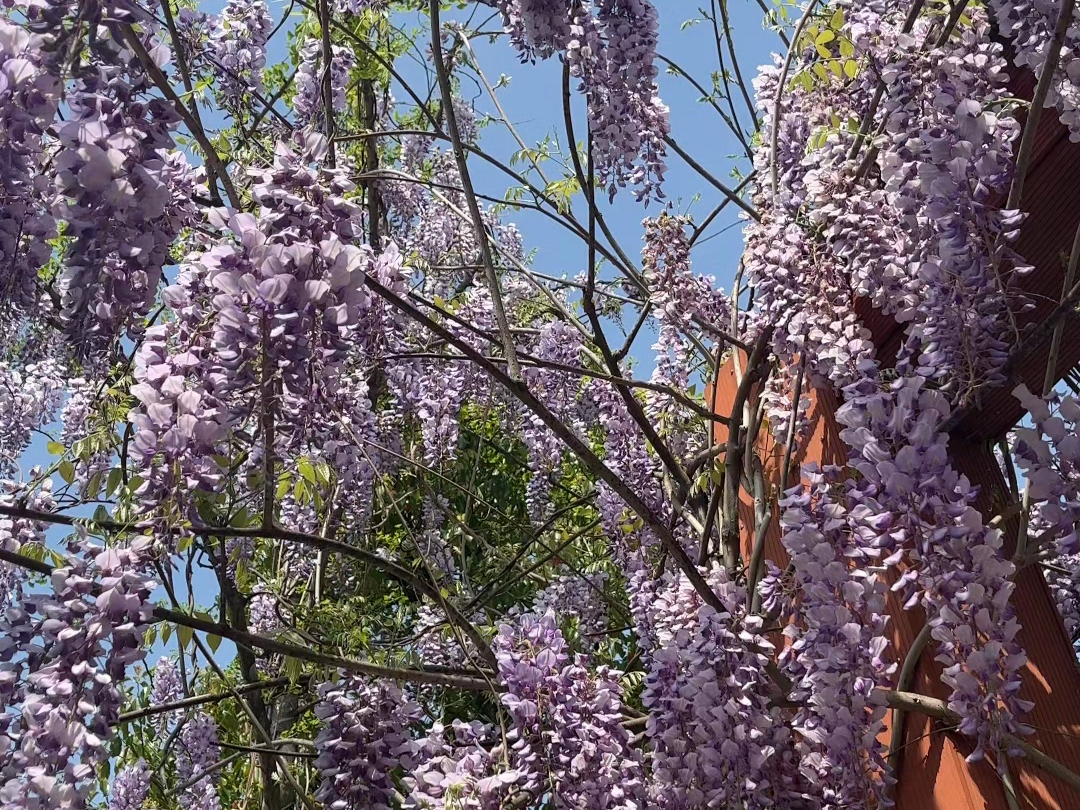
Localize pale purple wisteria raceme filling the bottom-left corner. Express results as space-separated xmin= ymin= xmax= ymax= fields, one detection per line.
xmin=0 ymin=536 xmax=154 ymax=810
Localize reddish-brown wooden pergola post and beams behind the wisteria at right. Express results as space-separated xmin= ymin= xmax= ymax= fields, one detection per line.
xmin=710 ymin=65 xmax=1080 ymax=810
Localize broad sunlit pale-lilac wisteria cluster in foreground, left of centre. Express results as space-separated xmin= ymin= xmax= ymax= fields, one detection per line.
xmin=131 ymin=134 xmax=370 ymax=520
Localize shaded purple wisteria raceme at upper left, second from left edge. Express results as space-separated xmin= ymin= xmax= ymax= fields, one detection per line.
xmin=46 ymin=12 xmax=198 ymax=357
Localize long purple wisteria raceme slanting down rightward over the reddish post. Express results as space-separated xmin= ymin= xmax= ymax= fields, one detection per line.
xmin=837 ymin=371 xmax=1030 ymax=759
